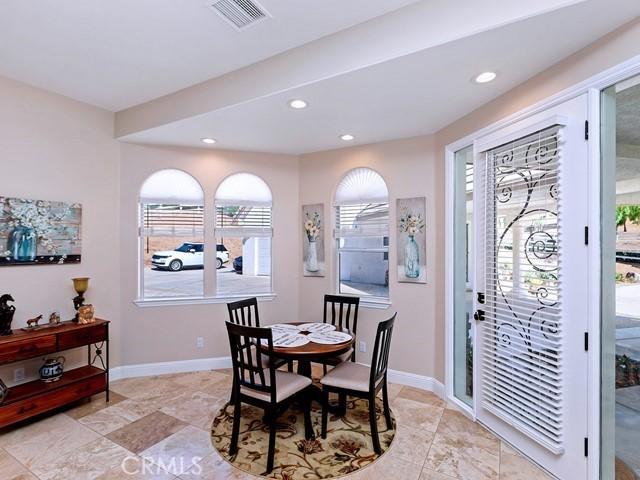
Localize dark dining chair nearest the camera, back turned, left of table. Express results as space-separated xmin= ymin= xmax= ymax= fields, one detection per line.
xmin=226 ymin=322 xmax=313 ymax=475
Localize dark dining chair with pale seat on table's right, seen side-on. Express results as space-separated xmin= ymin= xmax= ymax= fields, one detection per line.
xmin=320 ymin=313 xmax=397 ymax=455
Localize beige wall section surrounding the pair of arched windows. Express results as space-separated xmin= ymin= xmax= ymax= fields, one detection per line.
xmin=120 ymin=144 xmax=301 ymax=365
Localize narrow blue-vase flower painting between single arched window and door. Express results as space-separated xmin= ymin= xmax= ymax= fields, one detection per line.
xmin=396 ymin=197 xmax=427 ymax=283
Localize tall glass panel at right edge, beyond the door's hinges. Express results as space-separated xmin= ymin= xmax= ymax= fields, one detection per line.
xmin=601 ymin=77 xmax=640 ymax=480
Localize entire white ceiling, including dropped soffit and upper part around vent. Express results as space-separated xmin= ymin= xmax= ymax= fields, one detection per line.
xmin=0 ymin=0 xmax=640 ymax=154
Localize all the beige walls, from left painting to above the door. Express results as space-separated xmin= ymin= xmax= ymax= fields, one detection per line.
xmin=0 ymin=15 xmax=640 ymax=381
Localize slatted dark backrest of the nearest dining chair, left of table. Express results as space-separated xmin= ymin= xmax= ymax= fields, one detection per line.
xmin=226 ymin=322 xmax=276 ymax=403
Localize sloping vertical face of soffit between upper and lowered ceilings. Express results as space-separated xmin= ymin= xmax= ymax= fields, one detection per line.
xmin=116 ymin=0 xmax=584 ymax=137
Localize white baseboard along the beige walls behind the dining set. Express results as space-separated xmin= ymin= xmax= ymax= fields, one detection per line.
xmin=109 ymin=357 xmax=445 ymax=399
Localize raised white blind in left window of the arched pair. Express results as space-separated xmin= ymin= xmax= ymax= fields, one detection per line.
xmin=141 ymin=203 xmax=204 ymax=238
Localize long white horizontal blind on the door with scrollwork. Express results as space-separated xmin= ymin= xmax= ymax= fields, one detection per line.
xmin=477 ymin=126 xmax=566 ymax=454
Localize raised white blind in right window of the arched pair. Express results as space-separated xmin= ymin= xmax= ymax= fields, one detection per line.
xmin=216 ymin=205 xmax=273 ymax=237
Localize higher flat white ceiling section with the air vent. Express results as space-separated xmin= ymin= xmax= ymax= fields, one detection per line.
xmin=0 ymin=0 xmax=417 ymax=111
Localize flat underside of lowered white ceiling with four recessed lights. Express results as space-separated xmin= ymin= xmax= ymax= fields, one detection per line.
xmin=120 ymin=0 xmax=640 ymax=154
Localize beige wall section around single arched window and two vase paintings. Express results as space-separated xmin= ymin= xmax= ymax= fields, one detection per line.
xmin=297 ymin=136 xmax=442 ymax=376
